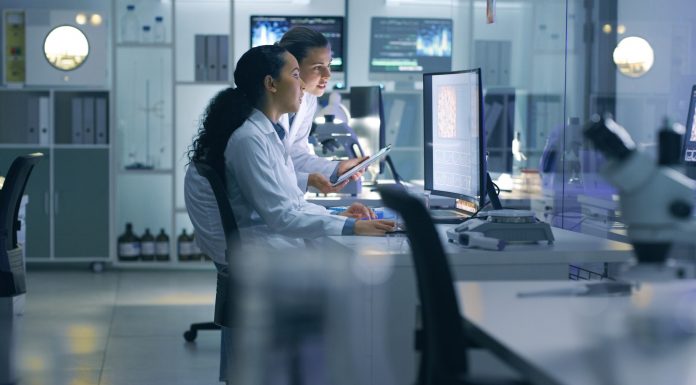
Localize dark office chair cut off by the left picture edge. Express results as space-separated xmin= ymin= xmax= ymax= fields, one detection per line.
xmin=0 ymin=152 xmax=43 ymax=297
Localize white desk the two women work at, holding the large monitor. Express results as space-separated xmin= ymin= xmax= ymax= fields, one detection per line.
xmin=322 ymin=225 xmax=633 ymax=385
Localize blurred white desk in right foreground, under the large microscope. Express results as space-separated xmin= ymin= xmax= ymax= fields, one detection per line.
xmin=456 ymin=281 xmax=696 ymax=385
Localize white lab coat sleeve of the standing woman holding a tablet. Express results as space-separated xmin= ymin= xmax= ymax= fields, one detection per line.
xmin=289 ymin=98 xmax=338 ymax=179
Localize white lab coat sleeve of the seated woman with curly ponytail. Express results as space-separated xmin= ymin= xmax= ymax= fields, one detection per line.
xmin=225 ymin=136 xmax=347 ymax=238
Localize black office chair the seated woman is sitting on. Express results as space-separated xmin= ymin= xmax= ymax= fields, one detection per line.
xmin=184 ymin=162 xmax=240 ymax=342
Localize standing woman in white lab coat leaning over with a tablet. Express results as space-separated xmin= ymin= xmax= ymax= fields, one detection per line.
xmin=278 ymin=27 xmax=365 ymax=193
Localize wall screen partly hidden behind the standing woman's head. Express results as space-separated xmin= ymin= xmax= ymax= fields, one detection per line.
xmin=249 ymin=16 xmax=344 ymax=72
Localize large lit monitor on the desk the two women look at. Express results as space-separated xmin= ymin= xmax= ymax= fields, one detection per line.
xmin=423 ymin=69 xmax=486 ymax=208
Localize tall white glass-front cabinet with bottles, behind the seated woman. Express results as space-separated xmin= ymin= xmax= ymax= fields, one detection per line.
xmin=111 ymin=0 xmax=232 ymax=267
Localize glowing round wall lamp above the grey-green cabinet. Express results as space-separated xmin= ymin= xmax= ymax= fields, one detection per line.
xmin=44 ymin=25 xmax=89 ymax=71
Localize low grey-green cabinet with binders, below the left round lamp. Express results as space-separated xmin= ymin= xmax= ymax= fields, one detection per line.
xmin=0 ymin=89 xmax=111 ymax=262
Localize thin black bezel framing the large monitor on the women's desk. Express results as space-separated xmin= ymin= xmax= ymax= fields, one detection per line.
xmin=423 ymin=68 xmax=488 ymax=209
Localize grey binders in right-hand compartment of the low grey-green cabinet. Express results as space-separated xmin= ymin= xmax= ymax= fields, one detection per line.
xmin=71 ymin=97 xmax=109 ymax=144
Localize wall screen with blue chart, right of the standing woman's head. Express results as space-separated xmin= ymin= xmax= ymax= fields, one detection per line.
xmin=370 ymin=17 xmax=452 ymax=82
